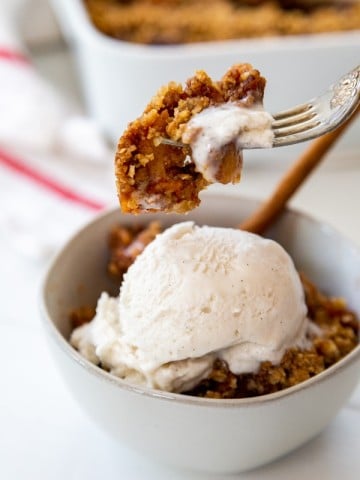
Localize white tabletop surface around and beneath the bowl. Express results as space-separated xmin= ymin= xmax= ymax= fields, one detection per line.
xmin=0 ymin=46 xmax=360 ymax=480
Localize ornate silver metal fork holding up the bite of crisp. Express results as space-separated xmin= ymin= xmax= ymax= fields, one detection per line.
xmin=161 ymin=65 xmax=360 ymax=148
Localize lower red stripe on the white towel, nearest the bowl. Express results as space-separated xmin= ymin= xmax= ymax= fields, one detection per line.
xmin=0 ymin=150 xmax=105 ymax=211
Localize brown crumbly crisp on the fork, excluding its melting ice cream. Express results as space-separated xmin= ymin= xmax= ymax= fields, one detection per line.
xmin=115 ymin=63 xmax=265 ymax=214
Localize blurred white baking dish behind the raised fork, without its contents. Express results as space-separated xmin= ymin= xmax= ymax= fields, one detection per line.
xmin=52 ymin=0 xmax=360 ymax=154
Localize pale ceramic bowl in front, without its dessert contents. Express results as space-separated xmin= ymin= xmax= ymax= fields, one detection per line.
xmin=42 ymin=195 xmax=360 ymax=472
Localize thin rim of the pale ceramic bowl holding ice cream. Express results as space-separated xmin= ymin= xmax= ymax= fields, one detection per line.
xmin=39 ymin=192 xmax=360 ymax=408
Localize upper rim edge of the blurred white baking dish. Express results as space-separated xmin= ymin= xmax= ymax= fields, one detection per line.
xmin=52 ymin=0 xmax=360 ymax=58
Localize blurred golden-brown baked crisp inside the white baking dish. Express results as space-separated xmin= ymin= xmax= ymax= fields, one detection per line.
xmin=84 ymin=0 xmax=360 ymax=45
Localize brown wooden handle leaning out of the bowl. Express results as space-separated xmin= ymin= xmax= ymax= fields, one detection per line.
xmin=239 ymin=107 xmax=360 ymax=233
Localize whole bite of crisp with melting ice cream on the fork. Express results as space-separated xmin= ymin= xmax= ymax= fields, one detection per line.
xmin=115 ymin=64 xmax=273 ymax=213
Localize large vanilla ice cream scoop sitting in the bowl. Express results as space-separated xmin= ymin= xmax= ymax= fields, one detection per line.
xmin=72 ymin=222 xmax=308 ymax=391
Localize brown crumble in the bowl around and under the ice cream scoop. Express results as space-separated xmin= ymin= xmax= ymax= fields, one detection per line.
xmin=70 ymin=222 xmax=360 ymax=399
